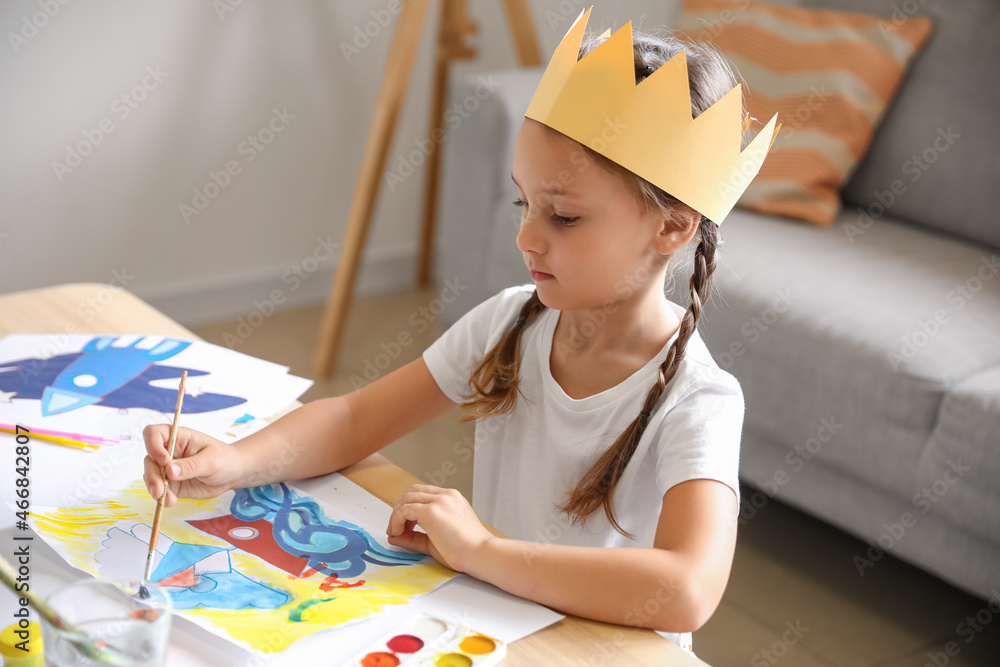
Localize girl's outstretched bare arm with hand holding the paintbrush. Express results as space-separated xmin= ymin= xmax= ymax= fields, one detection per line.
xmin=143 ymin=358 xmax=454 ymax=507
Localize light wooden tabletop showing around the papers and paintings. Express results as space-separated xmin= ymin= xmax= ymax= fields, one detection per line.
xmin=0 ymin=283 xmax=705 ymax=667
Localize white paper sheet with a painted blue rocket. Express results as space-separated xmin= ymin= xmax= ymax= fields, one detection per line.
xmin=0 ymin=334 xmax=312 ymax=443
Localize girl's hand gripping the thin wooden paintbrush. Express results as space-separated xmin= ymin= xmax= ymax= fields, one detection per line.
xmin=142 ymin=424 xmax=243 ymax=507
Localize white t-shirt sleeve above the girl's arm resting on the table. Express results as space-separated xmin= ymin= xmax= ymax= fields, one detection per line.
xmin=653 ymin=369 xmax=744 ymax=505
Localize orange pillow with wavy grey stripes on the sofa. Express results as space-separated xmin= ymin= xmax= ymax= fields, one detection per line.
xmin=677 ymin=0 xmax=931 ymax=227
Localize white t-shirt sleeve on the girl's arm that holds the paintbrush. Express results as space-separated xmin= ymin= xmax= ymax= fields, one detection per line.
xmin=423 ymin=285 xmax=535 ymax=403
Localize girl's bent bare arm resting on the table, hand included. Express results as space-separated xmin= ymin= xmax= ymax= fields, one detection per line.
xmin=387 ymin=479 xmax=737 ymax=632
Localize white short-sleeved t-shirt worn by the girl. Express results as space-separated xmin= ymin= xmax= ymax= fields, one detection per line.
xmin=423 ymin=285 xmax=744 ymax=646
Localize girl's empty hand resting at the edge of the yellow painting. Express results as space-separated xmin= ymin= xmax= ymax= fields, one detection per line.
xmin=385 ymin=484 xmax=494 ymax=572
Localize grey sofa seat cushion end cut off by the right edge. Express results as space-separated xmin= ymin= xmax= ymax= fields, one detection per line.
xmin=914 ymin=368 xmax=1000 ymax=542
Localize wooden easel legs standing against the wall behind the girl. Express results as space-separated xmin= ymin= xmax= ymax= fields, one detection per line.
xmin=313 ymin=0 xmax=541 ymax=380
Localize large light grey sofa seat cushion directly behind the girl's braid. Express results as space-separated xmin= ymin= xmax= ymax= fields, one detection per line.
xmin=688 ymin=210 xmax=1000 ymax=499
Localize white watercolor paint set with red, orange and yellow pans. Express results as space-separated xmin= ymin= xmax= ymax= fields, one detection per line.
xmin=347 ymin=614 xmax=507 ymax=667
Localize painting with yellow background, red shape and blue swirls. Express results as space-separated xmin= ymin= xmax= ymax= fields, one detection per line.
xmin=32 ymin=482 xmax=456 ymax=652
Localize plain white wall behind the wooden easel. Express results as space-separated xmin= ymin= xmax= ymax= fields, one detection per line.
xmin=0 ymin=0 xmax=676 ymax=326
